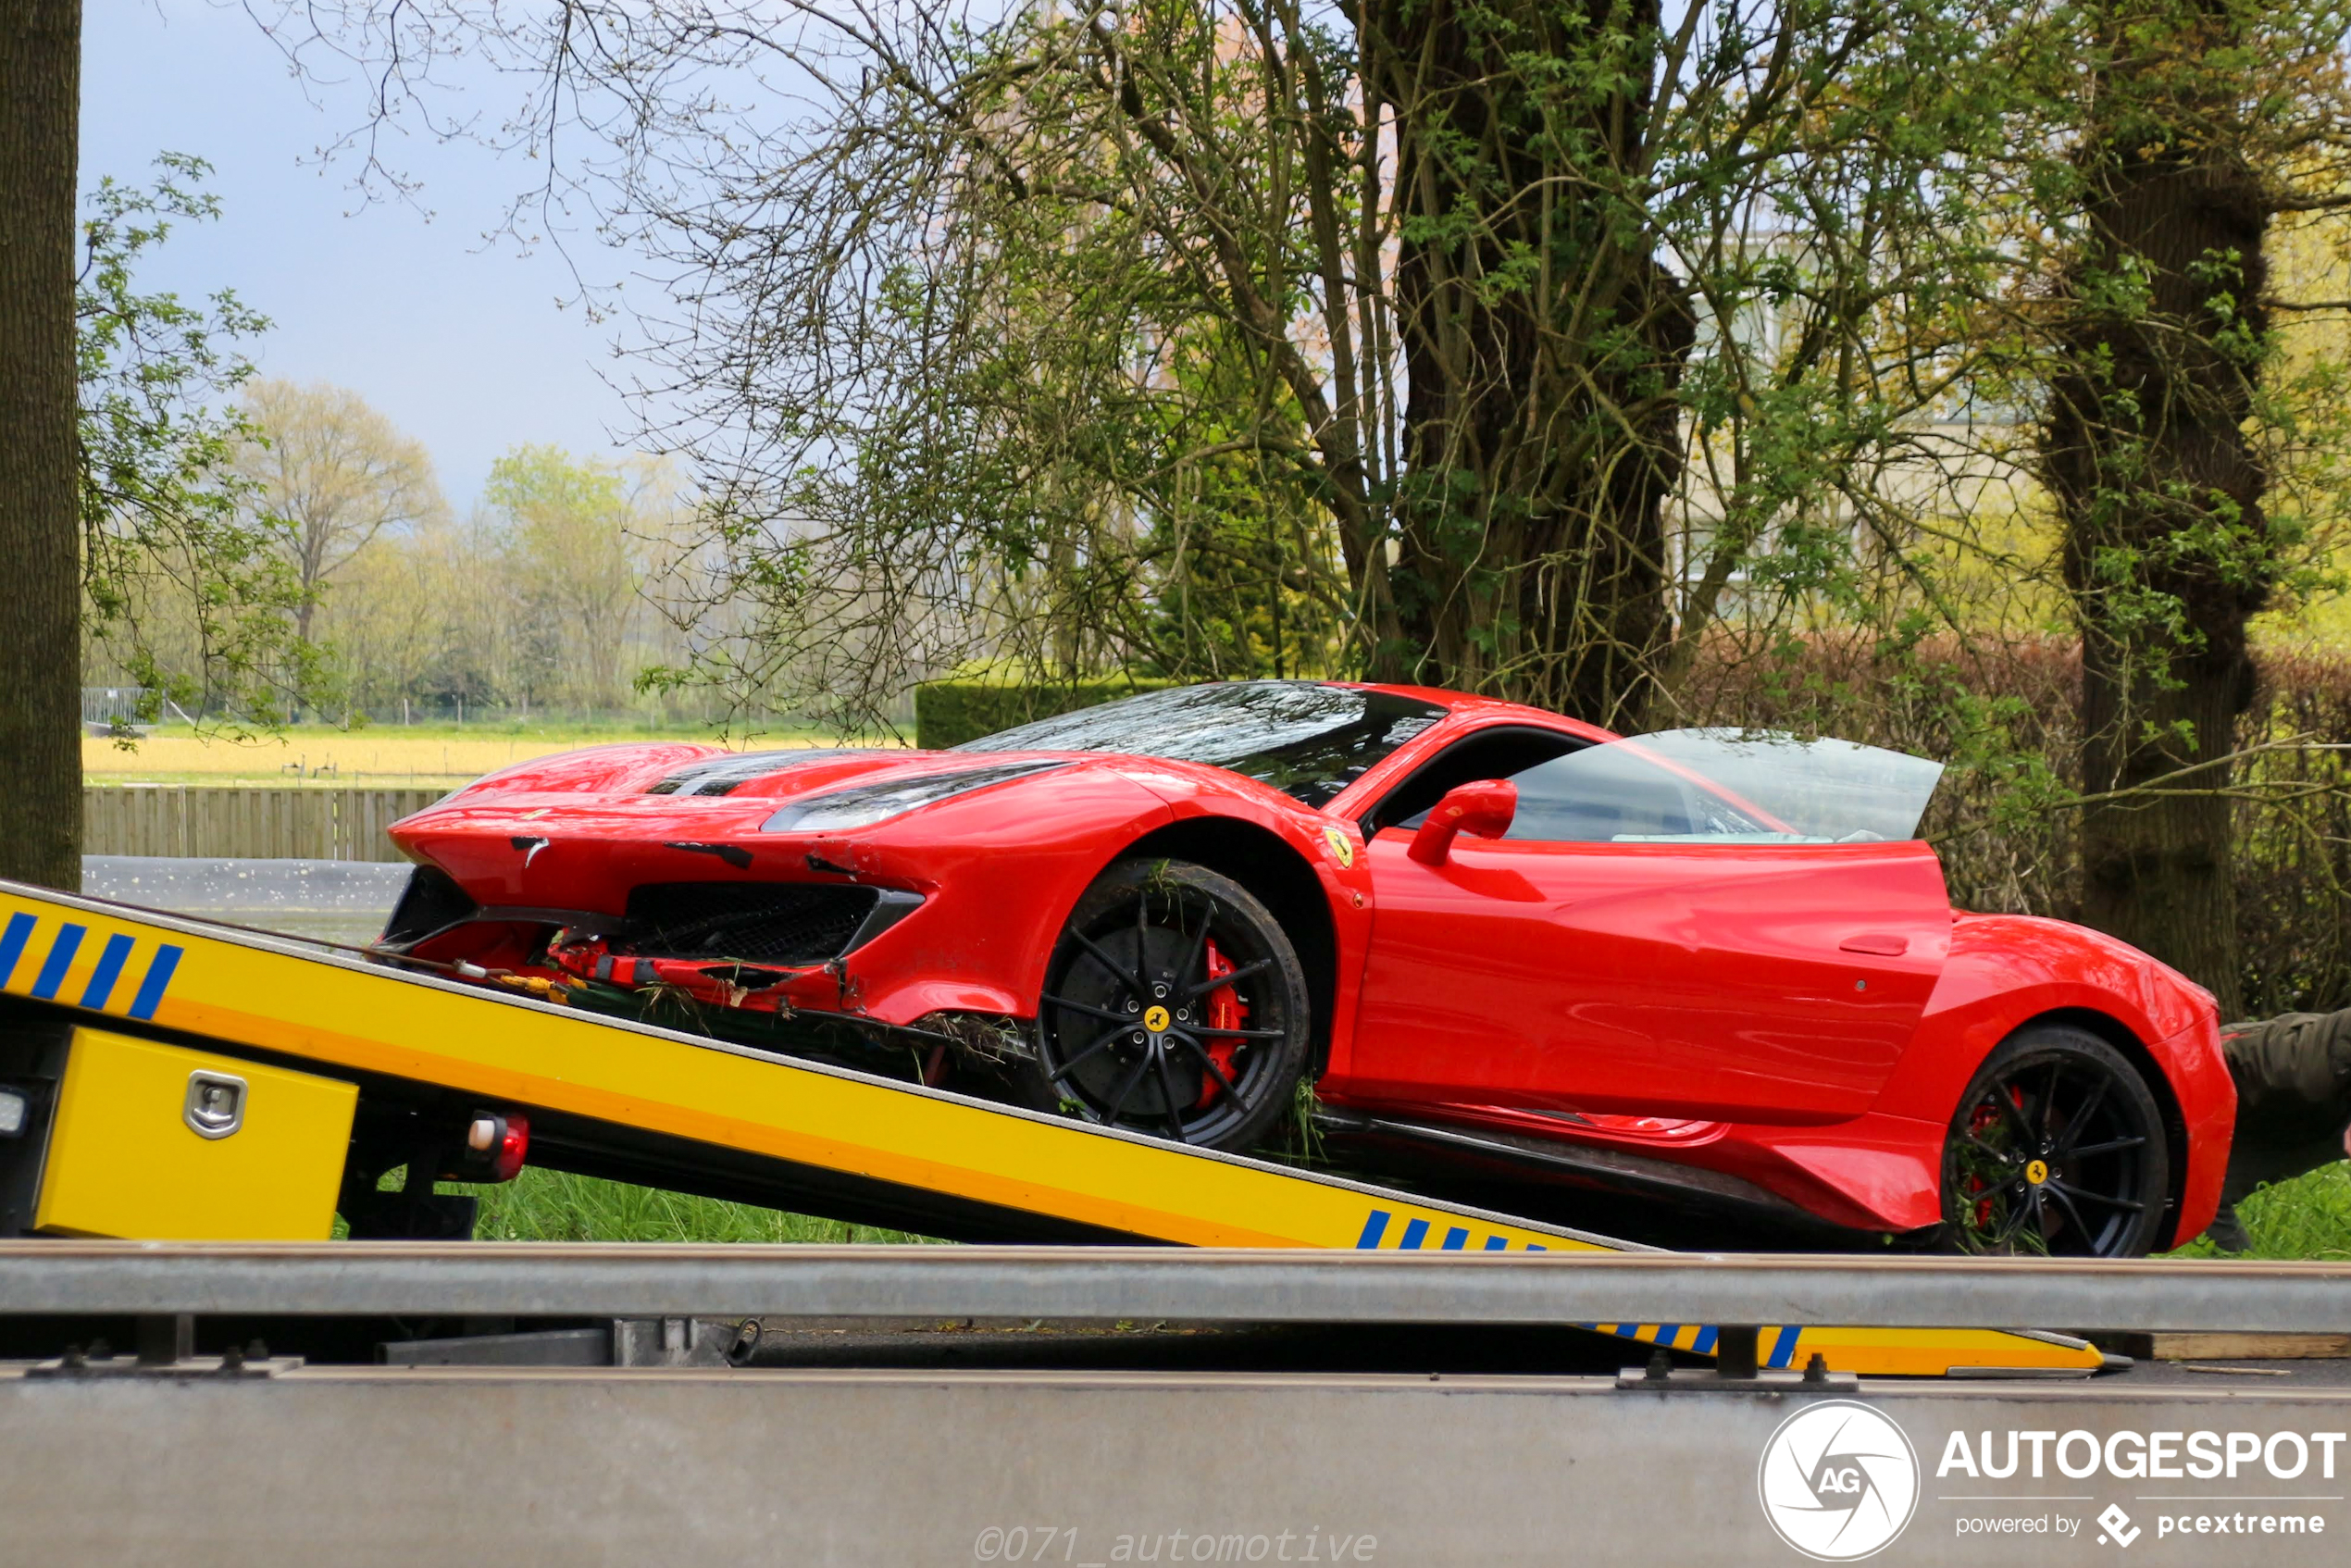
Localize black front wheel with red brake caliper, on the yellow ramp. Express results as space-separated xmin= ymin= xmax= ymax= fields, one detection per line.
xmin=1014 ymin=861 xmax=1312 ymax=1150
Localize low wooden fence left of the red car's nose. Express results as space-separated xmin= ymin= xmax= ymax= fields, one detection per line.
xmin=82 ymin=785 xmax=444 ymax=861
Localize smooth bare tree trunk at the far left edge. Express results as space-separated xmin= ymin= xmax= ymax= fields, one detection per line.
xmin=0 ymin=0 xmax=82 ymax=889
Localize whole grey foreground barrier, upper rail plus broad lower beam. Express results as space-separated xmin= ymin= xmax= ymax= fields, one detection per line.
xmin=0 ymin=1241 xmax=2351 ymax=1568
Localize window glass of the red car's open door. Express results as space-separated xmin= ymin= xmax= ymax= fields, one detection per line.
xmin=1510 ymin=728 xmax=1942 ymax=844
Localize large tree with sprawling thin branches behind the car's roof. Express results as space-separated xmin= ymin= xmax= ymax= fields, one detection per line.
xmin=247 ymin=0 xmax=2059 ymax=724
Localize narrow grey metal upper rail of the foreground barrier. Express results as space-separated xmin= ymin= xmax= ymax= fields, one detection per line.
xmin=0 ymin=1238 xmax=2351 ymax=1336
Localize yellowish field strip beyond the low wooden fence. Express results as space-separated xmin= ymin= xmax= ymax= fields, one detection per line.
xmin=82 ymin=724 xmax=889 ymax=788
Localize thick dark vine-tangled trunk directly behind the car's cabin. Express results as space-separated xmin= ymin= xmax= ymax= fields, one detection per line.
xmin=1375 ymin=0 xmax=1695 ymax=727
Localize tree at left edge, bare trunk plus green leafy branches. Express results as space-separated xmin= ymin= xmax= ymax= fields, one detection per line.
xmin=0 ymin=15 xmax=299 ymax=889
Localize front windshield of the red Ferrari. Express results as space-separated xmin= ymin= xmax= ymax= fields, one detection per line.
xmin=954 ymin=682 xmax=1446 ymax=806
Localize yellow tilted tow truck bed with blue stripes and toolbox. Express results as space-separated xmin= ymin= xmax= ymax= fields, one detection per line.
xmin=0 ymin=881 xmax=2104 ymax=1375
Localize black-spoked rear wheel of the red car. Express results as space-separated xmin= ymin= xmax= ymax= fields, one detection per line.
xmin=1942 ymin=1025 xmax=2172 ymax=1258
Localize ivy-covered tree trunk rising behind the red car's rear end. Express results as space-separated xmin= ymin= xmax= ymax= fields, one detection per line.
xmin=2043 ymin=0 xmax=2273 ymax=1018
